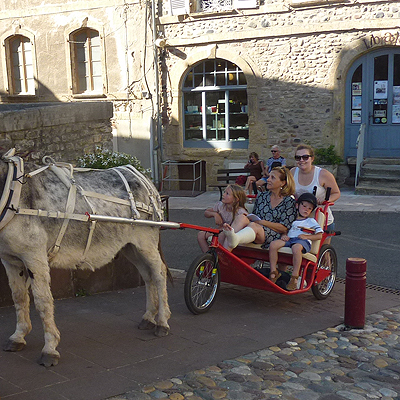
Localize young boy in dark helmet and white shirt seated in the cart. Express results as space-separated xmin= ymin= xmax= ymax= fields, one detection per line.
xmin=269 ymin=193 xmax=323 ymax=290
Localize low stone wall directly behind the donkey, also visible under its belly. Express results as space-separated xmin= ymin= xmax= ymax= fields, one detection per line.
xmin=0 ymin=102 xmax=143 ymax=307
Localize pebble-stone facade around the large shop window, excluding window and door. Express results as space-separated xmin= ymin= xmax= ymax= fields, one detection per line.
xmin=161 ymin=0 xmax=400 ymax=183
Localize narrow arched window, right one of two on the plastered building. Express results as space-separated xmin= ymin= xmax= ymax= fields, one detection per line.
xmin=71 ymin=28 xmax=103 ymax=94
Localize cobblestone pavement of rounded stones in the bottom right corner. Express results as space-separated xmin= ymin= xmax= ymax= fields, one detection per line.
xmin=110 ymin=308 xmax=400 ymax=400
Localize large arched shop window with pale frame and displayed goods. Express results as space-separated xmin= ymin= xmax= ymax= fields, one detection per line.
xmin=182 ymin=59 xmax=249 ymax=148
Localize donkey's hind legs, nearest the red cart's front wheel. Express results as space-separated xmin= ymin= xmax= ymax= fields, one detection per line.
xmin=124 ymin=238 xmax=171 ymax=336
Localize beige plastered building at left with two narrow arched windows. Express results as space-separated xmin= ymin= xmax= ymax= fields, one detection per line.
xmin=0 ymin=0 xmax=157 ymax=168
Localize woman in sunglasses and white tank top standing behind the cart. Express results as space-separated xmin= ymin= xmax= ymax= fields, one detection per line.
xmin=290 ymin=144 xmax=340 ymax=230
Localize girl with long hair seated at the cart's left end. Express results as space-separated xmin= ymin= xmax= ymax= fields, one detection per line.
xmin=197 ymin=184 xmax=247 ymax=253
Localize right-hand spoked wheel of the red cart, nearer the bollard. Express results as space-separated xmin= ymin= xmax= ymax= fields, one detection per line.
xmin=311 ymin=244 xmax=337 ymax=300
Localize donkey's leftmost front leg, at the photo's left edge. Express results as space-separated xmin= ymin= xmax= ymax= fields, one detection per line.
xmin=2 ymin=260 xmax=32 ymax=351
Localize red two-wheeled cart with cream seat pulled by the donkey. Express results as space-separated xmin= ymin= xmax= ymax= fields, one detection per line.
xmin=180 ymin=197 xmax=340 ymax=314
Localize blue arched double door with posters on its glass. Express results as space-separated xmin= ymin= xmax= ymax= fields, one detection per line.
xmin=345 ymin=48 xmax=400 ymax=158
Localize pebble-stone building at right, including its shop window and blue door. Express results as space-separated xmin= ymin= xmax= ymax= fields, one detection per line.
xmin=159 ymin=0 xmax=400 ymax=188
